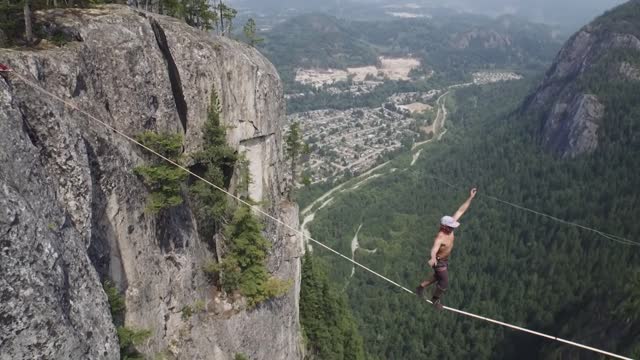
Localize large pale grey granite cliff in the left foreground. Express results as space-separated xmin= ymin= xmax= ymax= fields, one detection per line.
xmin=0 ymin=6 xmax=302 ymax=360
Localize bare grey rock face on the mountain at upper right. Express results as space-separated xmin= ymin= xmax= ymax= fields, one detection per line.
xmin=522 ymin=0 xmax=640 ymax=158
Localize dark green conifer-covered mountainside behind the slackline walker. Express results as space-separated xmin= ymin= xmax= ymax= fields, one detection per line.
xmin=310 ymin=1 xmax=640 ymax=359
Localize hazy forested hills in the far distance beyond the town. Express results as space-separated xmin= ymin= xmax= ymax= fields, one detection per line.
xmin=261 ymin=14 xmax=560 ymax=81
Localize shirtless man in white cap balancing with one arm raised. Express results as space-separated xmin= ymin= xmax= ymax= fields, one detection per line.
xmin=416 ymin=188 xmax=478 ymax=309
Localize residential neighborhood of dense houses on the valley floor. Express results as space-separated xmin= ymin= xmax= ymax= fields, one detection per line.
xmin=288 ymin=93 xmax=434 ymax=183
